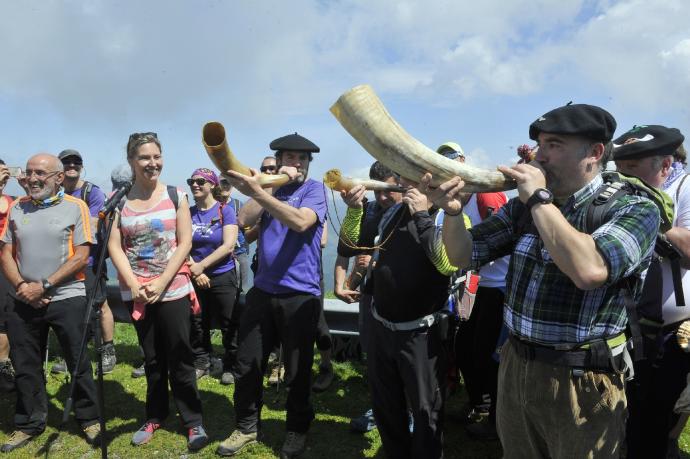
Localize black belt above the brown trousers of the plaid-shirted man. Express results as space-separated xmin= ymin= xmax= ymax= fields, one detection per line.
xmin=510 ymin=334 xmax=624 ymax=372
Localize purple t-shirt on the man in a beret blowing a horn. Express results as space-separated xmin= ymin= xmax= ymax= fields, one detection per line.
xmin=254 ymin=179 xmax=328 ymax=296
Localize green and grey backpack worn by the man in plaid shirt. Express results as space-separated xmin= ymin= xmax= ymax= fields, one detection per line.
xmin=513 ymin=171 xmax=685 ymax=361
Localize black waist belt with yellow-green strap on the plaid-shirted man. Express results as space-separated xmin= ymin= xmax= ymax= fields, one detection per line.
xmin=510 ymin=334 xmax=627 ymax=372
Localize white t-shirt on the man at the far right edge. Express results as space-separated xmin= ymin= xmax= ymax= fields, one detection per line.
xmin=661 ymin=175 xmax=690 ymax=325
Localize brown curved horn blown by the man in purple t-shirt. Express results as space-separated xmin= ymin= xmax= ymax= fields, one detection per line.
xmin=201 ymin=121 xmax=290 ymax=188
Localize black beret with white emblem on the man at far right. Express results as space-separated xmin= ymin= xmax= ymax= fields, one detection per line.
xmin=613 ymin=124 xmax=685 ymax=159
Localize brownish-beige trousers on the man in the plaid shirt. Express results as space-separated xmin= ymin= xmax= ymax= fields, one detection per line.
xmin=496 ymin=340 xmax=626 ymax=459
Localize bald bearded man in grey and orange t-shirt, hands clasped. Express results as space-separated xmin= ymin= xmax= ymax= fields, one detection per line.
xmin=0 ymin=154 xmax=100 ymax=452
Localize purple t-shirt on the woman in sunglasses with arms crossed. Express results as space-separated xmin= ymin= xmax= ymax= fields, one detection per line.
xmin=189 ymin=203 xmax=237 ymax=275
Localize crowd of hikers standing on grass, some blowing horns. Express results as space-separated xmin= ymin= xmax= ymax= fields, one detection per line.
xmin=0 ymin=104 xmax=690 ymax=458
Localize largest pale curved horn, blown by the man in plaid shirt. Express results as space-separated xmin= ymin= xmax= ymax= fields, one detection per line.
xmin=331 ymin=85 xmax=516 ymax=193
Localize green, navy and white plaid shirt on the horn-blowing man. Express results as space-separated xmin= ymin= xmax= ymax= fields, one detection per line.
xmin=469 ymin=175 xmax=659 ymax=345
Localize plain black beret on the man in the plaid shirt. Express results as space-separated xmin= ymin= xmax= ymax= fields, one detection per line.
xmin=529 ymin=104 xmax=616 ymax=143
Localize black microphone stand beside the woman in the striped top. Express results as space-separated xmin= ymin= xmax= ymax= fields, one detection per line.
xmin=62 ymin=196 xmax=124 ymax=459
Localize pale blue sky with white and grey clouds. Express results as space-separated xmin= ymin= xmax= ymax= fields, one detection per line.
xmin=0 ymin=0 xmax=690 ymax=198
